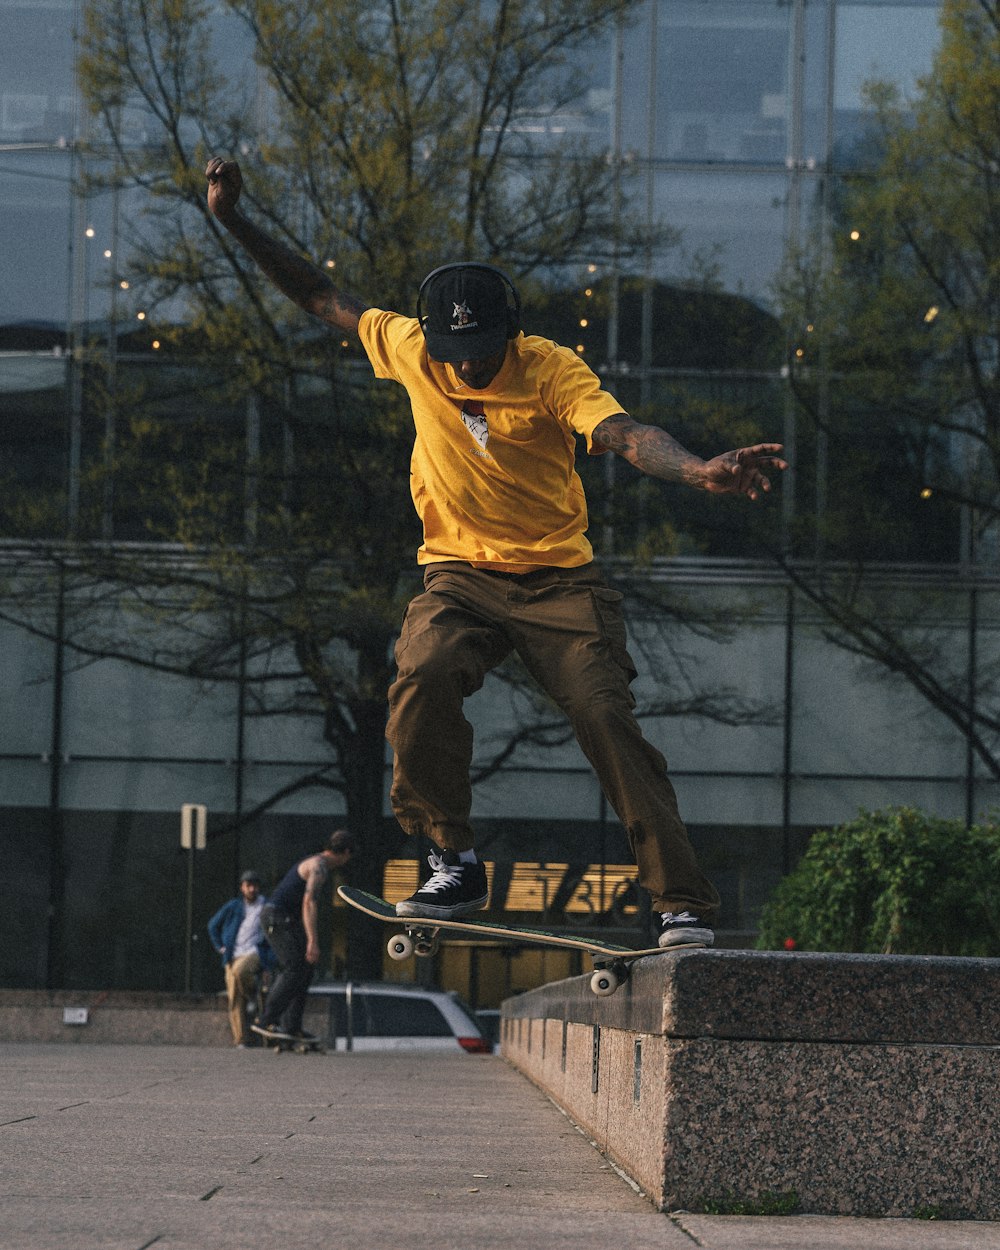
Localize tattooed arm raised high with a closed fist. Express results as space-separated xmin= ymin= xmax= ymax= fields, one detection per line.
xmin=205 ymin=156 xmax=368 ymax=334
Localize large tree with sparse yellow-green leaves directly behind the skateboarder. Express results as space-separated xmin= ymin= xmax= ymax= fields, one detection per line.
xmin=21 ymin=0 xmax=774 ymax=955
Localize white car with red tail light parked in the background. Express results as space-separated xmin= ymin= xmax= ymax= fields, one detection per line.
xmin=304 ymin=981 xmax=493 ymax=1055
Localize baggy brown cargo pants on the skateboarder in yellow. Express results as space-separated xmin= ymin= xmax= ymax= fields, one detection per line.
xmin=386 ymin=564 xmax=719 ymax=923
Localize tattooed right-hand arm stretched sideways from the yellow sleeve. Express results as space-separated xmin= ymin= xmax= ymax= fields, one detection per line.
xmin=594 ymin=413 xmax=788 ymax=499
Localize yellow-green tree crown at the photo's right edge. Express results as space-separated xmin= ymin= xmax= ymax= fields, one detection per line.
xmin=781 ymin=0 xmax=1000 ymax=560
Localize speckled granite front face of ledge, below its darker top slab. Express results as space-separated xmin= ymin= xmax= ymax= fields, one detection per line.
xmin=663 ymin=1040 xmax=1000 ymax=1220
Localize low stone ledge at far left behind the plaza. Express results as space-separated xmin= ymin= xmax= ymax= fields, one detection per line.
xmin=0 ymin=990 xmax=233 ymax=1046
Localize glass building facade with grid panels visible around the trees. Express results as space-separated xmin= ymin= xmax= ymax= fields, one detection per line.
xmin=0 ymin=0 xmax=968 ymax=986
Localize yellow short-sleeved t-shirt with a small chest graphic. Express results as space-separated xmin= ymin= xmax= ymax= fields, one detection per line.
xmin=358 ymin=309 xmax=623 ymax=569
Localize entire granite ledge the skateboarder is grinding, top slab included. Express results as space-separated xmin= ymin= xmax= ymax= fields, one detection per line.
xmin=501 ymin=951 xmax=1000 ymax=1220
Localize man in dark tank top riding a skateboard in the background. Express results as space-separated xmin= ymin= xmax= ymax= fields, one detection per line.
xmin=253 ymin=829 xmax=354 ymax=1040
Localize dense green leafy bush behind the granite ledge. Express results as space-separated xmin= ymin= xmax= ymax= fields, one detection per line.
xmin=758 ymin=808 xmax=1000 ymax=958
